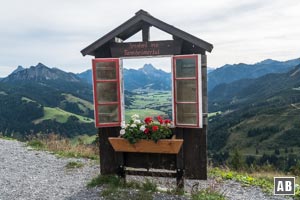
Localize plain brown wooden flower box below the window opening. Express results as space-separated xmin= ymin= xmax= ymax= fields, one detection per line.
xmin=108 ymin=137 xmax=183 ymax=154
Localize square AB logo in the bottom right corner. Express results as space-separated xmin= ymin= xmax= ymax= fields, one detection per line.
xmin=274 ymin=177 xmax=295 ymax=195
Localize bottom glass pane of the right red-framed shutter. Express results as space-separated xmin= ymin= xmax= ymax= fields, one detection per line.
xmin=176 ymin=104 xmax=198 ymax=125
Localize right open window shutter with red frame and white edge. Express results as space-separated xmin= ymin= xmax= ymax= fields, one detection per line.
xmin=172 ymin=55 xmax=202 ymax=128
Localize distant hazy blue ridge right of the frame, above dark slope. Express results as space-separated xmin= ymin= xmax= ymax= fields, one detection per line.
xmin=208 ymin=58 xmax=300 ymax=90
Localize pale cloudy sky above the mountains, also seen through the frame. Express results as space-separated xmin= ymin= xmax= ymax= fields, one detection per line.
xmin=0 ymin=0 xmax=300 ymax=77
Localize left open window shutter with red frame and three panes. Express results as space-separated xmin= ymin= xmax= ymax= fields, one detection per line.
xmin=93 ymin=58 xmax=122 ymax=127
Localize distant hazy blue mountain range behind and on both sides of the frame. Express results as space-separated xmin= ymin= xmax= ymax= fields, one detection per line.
xmin=77 ymin=58 xmax=300 ymax=91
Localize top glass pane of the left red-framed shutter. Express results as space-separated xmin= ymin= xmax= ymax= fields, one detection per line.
xmin=96 ymin=62 xmax=117 ymax=80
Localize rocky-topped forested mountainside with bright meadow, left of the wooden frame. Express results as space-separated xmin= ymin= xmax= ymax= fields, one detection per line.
xmin=0 ymin=63 xmax=95 ymax=138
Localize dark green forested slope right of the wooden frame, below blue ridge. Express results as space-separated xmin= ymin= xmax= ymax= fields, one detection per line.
xmin=208 ymin=65 xmax=300 ymax=158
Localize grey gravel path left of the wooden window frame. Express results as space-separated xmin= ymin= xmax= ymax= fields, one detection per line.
xmin=0 ymin=139 xmax=99 ymax=200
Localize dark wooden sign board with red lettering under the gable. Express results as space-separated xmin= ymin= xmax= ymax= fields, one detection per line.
xmin=110 ymin=40 xmax=182 ymax=58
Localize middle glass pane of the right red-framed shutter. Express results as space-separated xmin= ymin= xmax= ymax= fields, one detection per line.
xmin=176 ymin=80 xmax=197 ymax=102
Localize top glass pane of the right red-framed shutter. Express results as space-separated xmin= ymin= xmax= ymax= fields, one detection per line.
xmin=176 ymin=58 xmax=196 ymax=78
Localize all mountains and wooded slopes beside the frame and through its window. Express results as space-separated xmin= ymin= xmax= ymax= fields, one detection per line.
xmin=0 ymin=59 xmax=300 ymax=161
